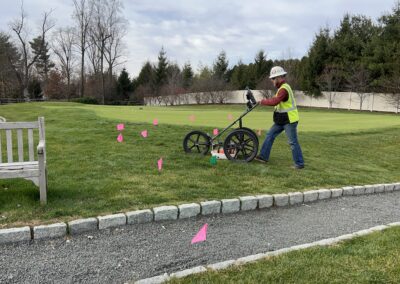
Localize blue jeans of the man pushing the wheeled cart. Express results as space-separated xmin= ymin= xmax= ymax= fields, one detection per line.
xmin=260 ymin=122 xmax=304 ymax=167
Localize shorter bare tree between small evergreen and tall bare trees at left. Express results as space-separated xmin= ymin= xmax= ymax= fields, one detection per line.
xmin=53 ymin=28 xmax=75 ymax=101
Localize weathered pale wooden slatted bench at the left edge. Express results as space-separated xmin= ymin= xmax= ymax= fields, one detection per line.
xmin=0 ymin=117 xmax=47 ymax=204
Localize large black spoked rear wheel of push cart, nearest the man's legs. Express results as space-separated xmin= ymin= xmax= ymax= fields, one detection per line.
xmin=224 ymin=128 xmax=258 ymax=162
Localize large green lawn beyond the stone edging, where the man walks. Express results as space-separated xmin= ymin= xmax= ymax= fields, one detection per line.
xmin=0 ymin=103 xmax=400 ymax=227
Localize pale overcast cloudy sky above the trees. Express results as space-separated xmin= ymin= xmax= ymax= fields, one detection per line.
xmin=0 ymin=0 xmax=395 ymax=76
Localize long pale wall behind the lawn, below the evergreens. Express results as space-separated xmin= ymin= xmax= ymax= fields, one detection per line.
xmin=145 ymin=90 xmax=399 ymax=113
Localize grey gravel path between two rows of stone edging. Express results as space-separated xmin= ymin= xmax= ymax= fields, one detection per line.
xmin=0 ymin=192 xmax=400 ymax=283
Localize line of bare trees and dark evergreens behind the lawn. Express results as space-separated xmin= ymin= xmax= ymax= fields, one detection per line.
xmin=0 ymin=0 xmax=400 ymax=109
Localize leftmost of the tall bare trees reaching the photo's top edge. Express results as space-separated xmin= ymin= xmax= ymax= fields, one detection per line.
xmin=73 ymin=0 xmax=93 ymax=97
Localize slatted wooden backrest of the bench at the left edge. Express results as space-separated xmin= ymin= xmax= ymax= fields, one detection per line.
xmin=0 ymin=117 xmax=46 ymax=163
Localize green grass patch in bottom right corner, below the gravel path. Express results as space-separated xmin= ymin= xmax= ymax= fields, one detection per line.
xmin=168 ymin=227 xmax=400 ymax=284
